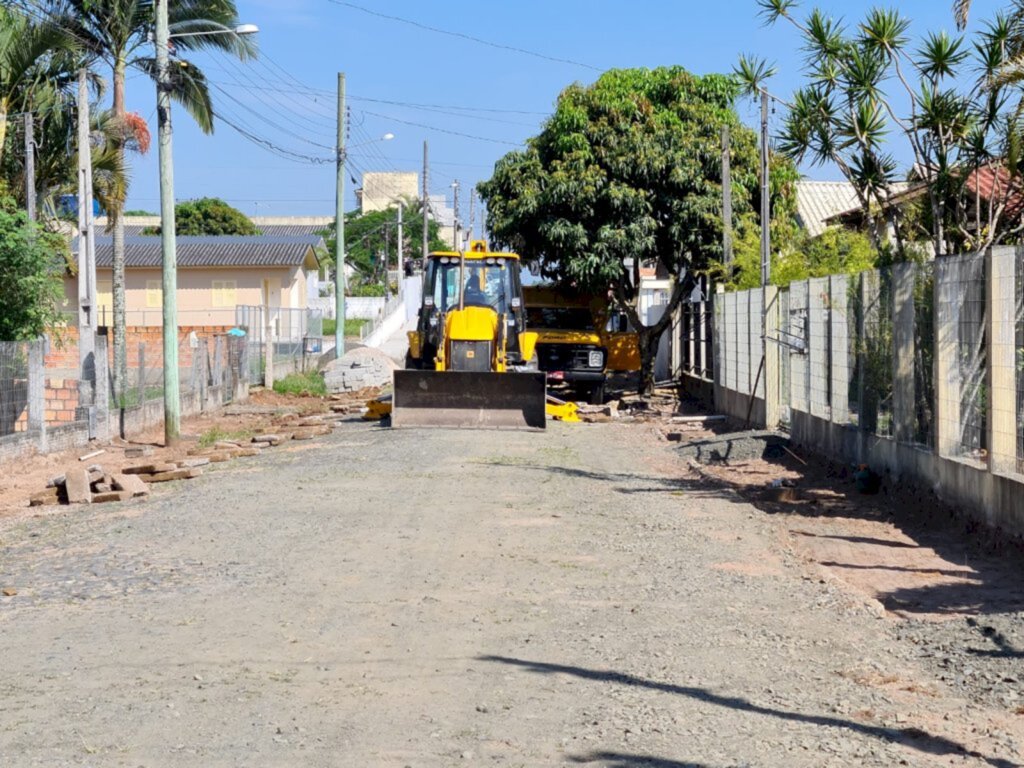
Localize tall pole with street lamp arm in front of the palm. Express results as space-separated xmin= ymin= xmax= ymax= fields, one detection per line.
xmin=156 ymin=0 xmax=259 ymax=445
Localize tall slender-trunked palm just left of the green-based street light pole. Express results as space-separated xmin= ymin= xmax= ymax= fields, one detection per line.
xmin=38 ymin=0 xmax=256 ymax=399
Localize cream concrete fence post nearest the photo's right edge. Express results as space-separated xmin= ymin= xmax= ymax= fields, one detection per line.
xmin=985 ymin=247 xmax=1017 ymax=474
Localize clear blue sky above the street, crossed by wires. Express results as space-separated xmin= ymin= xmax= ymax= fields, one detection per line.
xmin=117 ymin=0 xmax=1005 ymax=215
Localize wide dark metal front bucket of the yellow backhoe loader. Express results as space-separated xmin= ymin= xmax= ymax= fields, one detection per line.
xmin=391 ymin=371 xmax=546 ymax=429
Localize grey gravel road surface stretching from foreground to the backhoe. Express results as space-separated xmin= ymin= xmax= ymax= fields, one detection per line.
xmin=0 ymin=422 xmax=1024 ymax=768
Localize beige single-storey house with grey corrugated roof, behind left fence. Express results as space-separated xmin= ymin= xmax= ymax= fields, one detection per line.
xmin=65 ymin=234 xmax=323 ymax=327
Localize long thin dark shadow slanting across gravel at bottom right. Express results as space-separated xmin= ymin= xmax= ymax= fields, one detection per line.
xmin=477 ymin=655 xmax=1021 ymax=768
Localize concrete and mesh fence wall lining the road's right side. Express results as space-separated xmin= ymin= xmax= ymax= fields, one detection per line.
xmin=708 ymin=248 xmax=1024 ymax=536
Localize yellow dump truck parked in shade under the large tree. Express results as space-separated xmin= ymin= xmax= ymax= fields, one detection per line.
xmin=523 ymin=286 xmax=640 ymax=404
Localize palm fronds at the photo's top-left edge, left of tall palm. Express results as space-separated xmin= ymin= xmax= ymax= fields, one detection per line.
xmin=0 ymin=7 xmax=75 ymax=165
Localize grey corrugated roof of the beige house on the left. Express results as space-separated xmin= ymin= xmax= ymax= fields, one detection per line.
xmin=84 ymin=234 xmax=323 ymax=269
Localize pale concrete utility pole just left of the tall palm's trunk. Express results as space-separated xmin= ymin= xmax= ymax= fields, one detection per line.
xmin=78 ymin=70 xmax=97 ymax=404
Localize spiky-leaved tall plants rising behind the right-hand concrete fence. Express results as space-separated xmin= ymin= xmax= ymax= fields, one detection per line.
xmin=735 ymin=0 xmax=1024 ymax=261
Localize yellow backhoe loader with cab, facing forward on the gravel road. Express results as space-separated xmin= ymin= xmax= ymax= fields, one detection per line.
xmin=370 ymin=241 xmax=575 ymax=429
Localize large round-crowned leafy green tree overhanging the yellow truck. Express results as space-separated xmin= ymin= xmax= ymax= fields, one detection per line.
xmin=479 ymin=67 xmax=793 ymax=392
